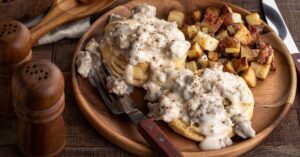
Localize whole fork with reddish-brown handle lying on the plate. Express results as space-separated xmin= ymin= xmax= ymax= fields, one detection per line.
xmin=89 ymin=64 xmax=183 ymax=157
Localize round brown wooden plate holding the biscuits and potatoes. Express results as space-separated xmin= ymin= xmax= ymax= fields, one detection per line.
xmin=72 ymin=0 xmax=296 ymax=157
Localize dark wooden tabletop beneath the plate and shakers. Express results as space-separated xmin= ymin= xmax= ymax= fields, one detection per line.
xmin=0 ymin=0 xmax=300 ymax=157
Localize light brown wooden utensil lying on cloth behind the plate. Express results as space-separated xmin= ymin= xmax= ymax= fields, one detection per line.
xmin=30 ymin=0 xmax=116 ymax=43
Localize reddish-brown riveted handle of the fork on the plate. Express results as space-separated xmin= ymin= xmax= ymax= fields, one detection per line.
xmin=138 ymin=118 xmax=183 ymax=157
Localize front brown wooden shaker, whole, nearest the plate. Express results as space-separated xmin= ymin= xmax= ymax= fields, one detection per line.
xmin=12 ymin=60 xmax=66 ymax=157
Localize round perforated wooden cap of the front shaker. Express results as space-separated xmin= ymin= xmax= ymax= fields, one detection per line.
xmin=12 ymin=59 xmax=64 ymax=111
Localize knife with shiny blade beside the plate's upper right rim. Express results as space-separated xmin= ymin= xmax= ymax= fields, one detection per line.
xmin=261 ymin=0 xmax=300 ymax=74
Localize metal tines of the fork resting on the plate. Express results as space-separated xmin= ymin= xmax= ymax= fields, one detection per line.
xmin=89 ymin=65 xmax=124 ymax=114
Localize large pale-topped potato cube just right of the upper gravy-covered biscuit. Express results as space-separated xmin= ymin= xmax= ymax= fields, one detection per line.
xmin=193 ymin=31 xmax=219 ymax=51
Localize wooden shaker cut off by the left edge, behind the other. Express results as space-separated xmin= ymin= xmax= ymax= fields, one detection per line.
xmin=0 ymin=20 xmax=32 ymax=118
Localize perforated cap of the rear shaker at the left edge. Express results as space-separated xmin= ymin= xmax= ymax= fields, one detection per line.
xmin=0 ymin=20 xmax=32 ymax=65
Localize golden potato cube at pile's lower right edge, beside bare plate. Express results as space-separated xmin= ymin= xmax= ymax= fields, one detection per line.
xmin=251 ymin=62 xmax=271 ymax=80
